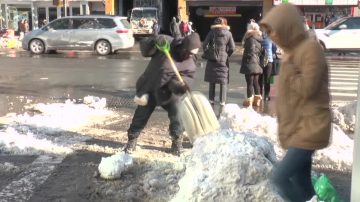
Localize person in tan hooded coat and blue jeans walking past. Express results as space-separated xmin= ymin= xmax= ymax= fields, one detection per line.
xmin=260 ymin=4 xmax=331 ymax=202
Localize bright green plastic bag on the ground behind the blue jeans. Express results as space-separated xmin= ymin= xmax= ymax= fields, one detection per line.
xmin=312 ymin=174 xmax=342 ymax=202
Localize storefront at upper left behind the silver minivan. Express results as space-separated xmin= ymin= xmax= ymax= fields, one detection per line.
xmin=0 ymin=0 xmax=105 ymax=31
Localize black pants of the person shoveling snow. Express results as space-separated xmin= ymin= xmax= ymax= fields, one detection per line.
xmin=128 ymin=94 xmax=184 ymax=140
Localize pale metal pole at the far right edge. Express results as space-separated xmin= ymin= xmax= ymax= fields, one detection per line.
xmin=351 ymin=69 xmax=360 ymax=202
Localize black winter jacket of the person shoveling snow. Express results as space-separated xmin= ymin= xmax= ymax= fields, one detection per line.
xmin=136 ymin=35 xmax=196 ymax=105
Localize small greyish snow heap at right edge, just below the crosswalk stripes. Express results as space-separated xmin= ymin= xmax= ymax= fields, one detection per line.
xmin=332 ymin=101 xmax=357 ymax=132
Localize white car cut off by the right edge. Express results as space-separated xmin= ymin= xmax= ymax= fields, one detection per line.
xmin=315 ymin=17 xmax=360 ymax=51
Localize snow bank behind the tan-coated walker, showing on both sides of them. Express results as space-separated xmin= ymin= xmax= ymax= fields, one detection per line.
xmin=219 ymin=104 xmax=354 ymax=171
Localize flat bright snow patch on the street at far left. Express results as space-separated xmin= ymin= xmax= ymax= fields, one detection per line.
xmin=0 ymin=97 xmax=114 ymax=155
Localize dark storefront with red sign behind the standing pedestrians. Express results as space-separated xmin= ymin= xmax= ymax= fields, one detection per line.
xmin=186 ymin=0 xmax=263 ymax=41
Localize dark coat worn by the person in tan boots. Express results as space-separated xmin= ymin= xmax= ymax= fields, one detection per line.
xmin=240 ymin=30 xmax=263 ymax=74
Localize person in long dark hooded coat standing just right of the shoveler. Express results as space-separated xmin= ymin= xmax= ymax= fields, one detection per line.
xmin=203 ymin=17 xmax=235 ymax=114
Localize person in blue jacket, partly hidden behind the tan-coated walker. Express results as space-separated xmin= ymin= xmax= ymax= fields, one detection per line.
xmin=259 ymin=32 xmax=276 ymax=101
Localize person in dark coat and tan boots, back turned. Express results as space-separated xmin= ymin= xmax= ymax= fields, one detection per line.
xmin=240 ymin=22 xmax=263 ymax=107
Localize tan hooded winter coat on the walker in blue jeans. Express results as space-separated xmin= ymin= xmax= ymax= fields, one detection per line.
xmin=261 ymin=4 xmax=331 ymax=150
